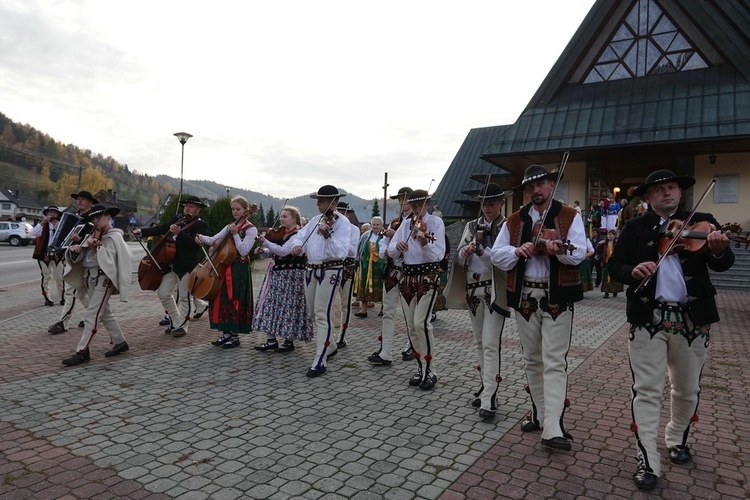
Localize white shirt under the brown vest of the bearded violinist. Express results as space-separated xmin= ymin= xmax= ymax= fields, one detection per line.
xmin=490 ymin=205 xmax=588 ymax=281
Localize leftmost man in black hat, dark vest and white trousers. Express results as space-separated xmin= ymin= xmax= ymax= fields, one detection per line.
xmin=29 ymin=206 xmax=65 ymax=306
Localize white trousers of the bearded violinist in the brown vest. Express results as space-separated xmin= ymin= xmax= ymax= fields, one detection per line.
xmin=516 ymin=288 xmax=573 ymax=439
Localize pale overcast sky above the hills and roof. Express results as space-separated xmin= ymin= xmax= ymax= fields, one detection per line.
xmin=0 ymin=0 xmax=594 ymax=198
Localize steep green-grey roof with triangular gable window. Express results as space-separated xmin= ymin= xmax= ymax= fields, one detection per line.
xmin=484 ymin=0 xmax=750 ymax=165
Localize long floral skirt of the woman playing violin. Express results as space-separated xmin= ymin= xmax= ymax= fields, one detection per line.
xmin=253 ymin=263 xmax=313 ymax=341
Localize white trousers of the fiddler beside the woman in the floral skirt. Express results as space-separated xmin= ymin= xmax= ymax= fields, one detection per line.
xmin=305 ymin=266 xmax=344 ymax=370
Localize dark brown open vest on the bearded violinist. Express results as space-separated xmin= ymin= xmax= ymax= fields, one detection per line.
xmin=507 ymin=200 xmax=583 ymax=308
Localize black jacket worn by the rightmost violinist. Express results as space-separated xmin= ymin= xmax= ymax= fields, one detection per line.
xmin=609 ymin=210 xmax=734 ymax=326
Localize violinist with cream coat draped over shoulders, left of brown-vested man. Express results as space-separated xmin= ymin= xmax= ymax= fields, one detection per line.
xmin=446 ymin=182 xmax=513 ymax=420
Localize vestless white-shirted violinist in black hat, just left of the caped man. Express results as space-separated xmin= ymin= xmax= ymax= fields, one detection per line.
xmin=388 ymin=189 xmax=445 ymax=391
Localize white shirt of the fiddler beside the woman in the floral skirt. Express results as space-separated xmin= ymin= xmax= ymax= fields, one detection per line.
xmin=289 ymin=214 xmax=352 ymax=264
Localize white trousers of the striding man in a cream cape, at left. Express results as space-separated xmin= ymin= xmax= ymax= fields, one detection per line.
xmin=76 ymin=268 xmax=125 ymax=352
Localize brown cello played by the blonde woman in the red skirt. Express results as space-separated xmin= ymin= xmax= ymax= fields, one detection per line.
xmin=187 ymin=204 xmax=258 ymax=301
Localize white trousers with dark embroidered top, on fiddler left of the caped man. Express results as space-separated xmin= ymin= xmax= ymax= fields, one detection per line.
xmin=399 ymin=273 xmax=439 ymax=380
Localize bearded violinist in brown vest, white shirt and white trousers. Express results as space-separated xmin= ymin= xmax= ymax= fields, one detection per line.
xmin=490 ymin=165 xmax=586 ymax=450
